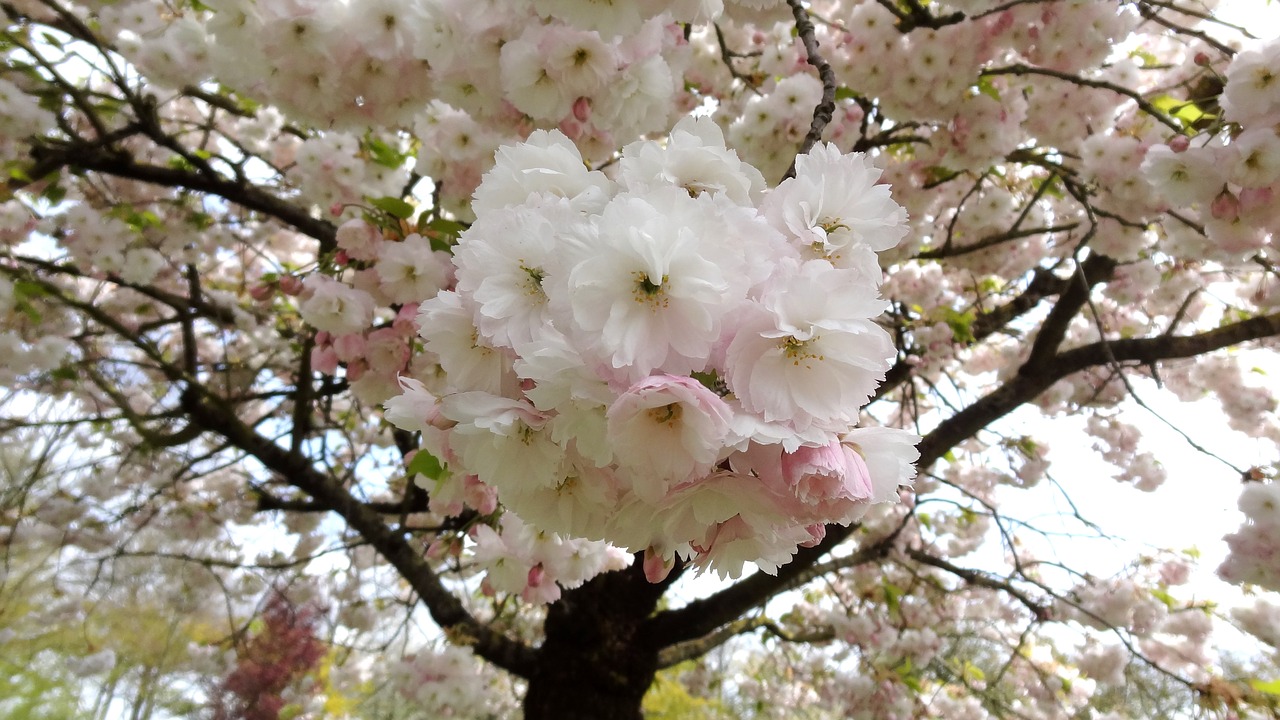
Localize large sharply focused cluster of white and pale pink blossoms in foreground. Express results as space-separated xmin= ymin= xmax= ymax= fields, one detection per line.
xmin=387 ymin=118 xmax=916 ymax=584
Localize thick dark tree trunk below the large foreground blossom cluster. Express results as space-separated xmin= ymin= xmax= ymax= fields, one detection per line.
xmin=525 ymin=561 xmax=667 ymax=720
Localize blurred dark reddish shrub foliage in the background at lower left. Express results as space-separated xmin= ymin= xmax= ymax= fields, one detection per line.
xmin=212 ymin=592 xmax=325 ymax=720
